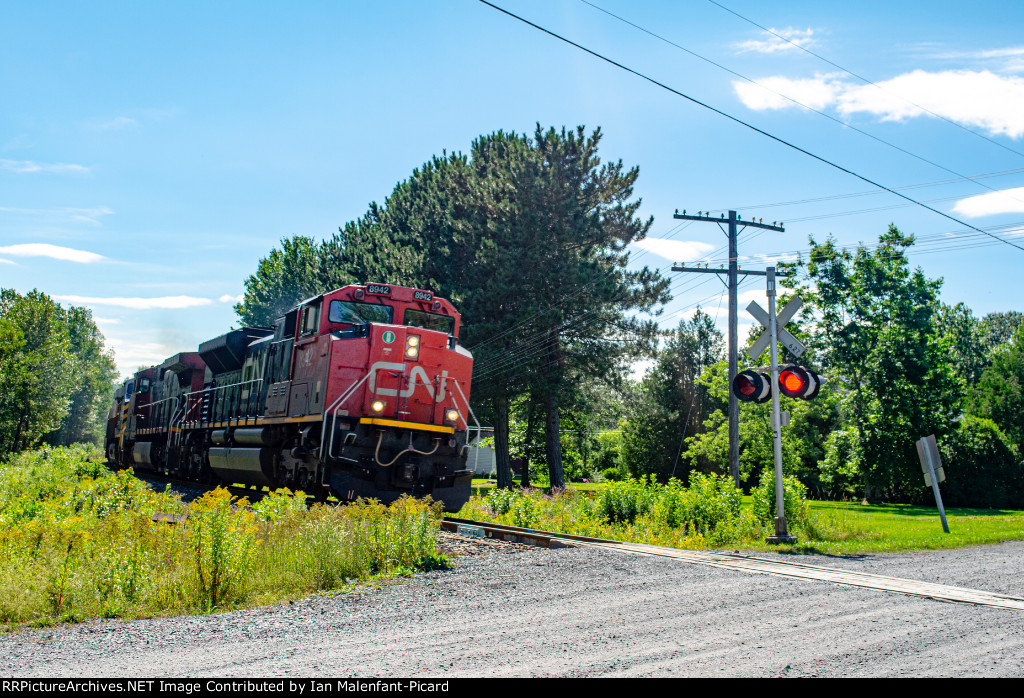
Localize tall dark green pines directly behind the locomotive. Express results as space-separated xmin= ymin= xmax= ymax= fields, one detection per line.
xmin=236 ymin=126 xmax=669 ymax=488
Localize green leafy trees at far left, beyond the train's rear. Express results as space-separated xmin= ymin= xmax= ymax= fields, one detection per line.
xmin=0 ymin=289 xmax=118 ymax=461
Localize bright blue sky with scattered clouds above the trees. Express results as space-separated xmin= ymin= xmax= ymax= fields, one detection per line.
xmin=0 ymin=0 xmax=1024 ymax=373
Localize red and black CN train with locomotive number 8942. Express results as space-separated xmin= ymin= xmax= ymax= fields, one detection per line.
xmin=104 ymin=283 xmax=479 ymax=512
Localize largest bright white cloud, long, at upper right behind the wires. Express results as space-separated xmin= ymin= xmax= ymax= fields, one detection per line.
xmin=733 ymin=70 xmax=1024 ymax=138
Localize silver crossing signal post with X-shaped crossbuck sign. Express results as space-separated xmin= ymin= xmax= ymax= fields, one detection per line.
xmin=746 ymin=266 xmax=806 ymax=543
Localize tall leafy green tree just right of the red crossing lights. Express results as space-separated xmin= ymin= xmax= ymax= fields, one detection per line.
xmin=797 ymin=226 xmax=963 ymax=499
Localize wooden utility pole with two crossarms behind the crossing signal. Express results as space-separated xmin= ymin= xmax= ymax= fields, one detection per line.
xmin=672 ymin=209 xmax=785 ymax=487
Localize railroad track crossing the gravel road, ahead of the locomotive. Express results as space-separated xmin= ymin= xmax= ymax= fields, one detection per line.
xmin=443 ymin=518 xmax=1024 ymax=611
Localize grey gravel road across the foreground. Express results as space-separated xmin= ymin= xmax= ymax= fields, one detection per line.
xmin=0 ymin=538 xmax=1024 ymax=678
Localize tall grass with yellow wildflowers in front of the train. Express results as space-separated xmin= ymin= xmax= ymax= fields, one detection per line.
xmin=0 ymin=448 xmax=446 ymax=628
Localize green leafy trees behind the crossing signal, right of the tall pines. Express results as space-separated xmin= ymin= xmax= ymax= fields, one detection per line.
xmin=621 ymin=226 xmax=1024 ymax=508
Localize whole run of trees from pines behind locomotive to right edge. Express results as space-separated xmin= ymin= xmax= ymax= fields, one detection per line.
xmin=236 ymin=126 xmax=1024 ymax=507
